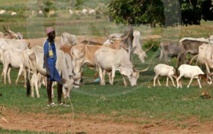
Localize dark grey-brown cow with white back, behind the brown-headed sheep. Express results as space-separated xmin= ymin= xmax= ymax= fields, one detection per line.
xmin=177 ymin=37 xmax=209 ymax=66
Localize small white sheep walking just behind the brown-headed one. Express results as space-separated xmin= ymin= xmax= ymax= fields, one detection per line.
xmin=153 ymin=64 xmax=177 ymax=87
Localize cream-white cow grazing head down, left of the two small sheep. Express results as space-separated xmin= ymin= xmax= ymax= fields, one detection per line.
xmin=95 ymin=47 xmax=148 ymax=86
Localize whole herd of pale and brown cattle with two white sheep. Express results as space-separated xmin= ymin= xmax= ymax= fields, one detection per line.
xmin=0 ymin=26 xmax=213 ymax=101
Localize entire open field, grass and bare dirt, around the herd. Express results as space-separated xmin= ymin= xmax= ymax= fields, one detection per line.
xmin=0 ymin=0 xmax=213 ymax=134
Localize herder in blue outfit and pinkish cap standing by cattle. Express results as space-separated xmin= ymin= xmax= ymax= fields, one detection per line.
xmin=43 ymin=27 xmax=64 ymax=106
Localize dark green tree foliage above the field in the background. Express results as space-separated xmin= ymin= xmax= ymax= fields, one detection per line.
xmin=108 ymin=0 xmax=213 ymax=26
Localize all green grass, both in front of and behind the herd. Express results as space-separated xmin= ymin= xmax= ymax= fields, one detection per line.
xmin=0 ymin=0 xmax=213 ymax=133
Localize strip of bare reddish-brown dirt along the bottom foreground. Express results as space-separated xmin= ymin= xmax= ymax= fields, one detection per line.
xmin=0 ymin=109 xmax=213 ymax=134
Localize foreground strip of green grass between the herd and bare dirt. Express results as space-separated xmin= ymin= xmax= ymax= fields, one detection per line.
xmin=0 ymin=62 xmax=213 ymax=121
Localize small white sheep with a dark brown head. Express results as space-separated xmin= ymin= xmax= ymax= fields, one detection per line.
xmin=177 ymin=64 xmax=212 ymax=88
